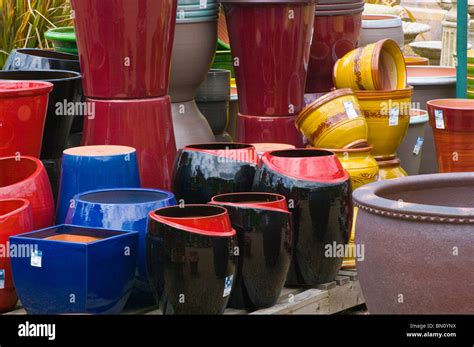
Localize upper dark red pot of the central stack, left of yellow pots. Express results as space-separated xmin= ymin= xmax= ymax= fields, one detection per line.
xmin=222 ymin=0 xmax=315 ymax=116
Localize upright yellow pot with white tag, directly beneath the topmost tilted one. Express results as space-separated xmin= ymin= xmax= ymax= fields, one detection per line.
xmin=356 ymin=86 xmax=413 ymax=158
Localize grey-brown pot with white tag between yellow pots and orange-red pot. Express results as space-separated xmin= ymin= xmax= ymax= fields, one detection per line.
xmin=397 ymin=109 xmax=429 ymax=176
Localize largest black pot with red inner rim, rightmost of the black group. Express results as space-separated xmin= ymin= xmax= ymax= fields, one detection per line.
xmin=254 ymin=149 xmax=353 ymax=285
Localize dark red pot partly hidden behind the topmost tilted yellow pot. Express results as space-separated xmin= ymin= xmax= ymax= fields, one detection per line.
xmin=305 ymin=3 xmax=363 ymax=93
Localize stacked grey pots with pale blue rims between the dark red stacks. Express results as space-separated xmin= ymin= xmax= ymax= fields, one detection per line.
xmin=170 ymin=0 xmax=219 ymax=149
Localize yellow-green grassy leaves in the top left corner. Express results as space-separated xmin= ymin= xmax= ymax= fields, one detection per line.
xmin=0 ymin=0 xmax=72 ymax=67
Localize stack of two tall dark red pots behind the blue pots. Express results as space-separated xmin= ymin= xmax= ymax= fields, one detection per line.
xmin=72 ymin=0 xmax=177 ymax=188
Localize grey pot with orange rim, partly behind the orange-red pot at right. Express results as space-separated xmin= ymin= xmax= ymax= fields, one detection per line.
xmin=407 ymin=66 xmax=456 ymax=174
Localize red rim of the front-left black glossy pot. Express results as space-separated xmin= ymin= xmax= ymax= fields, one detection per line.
xmin=148 ymin=204 xmax=237 ymax=237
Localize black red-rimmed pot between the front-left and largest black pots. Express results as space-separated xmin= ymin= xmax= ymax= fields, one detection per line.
xmin=212 ymin=193 xmax=292 ymax=310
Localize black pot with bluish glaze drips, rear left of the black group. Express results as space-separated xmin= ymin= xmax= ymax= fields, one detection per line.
xmin=173 ymin=143 xmax=257 ymax=204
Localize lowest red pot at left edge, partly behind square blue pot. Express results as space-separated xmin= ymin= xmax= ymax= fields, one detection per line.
xmin=0 ymin=199 xmax=33 ymax=312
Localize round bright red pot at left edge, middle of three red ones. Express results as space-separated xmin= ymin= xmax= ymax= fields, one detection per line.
xmin=0 ymin=157 xmax=54 ymax=230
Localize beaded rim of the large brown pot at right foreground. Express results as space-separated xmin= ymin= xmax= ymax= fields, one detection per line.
xmin=352 ymin=172 xmax=474 ymax=224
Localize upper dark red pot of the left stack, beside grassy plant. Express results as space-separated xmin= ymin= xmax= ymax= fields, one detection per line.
xmin=72 ymin=0 xmax=177 ymax=99
